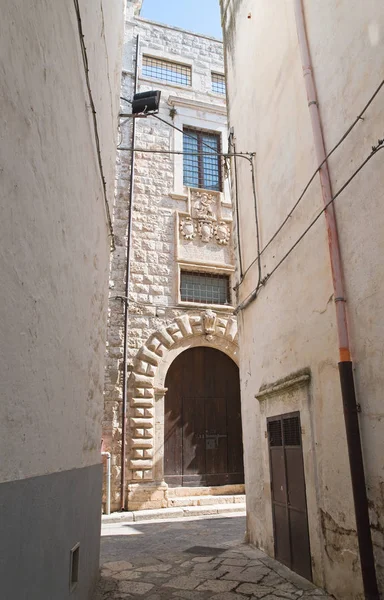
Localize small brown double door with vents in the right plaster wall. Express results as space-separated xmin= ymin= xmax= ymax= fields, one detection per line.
xmin=268 ymin=413 xmax=312 ymax=580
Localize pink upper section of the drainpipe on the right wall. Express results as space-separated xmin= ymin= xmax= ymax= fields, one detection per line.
xmin=295 ymin=0 xmax=351 ymax=362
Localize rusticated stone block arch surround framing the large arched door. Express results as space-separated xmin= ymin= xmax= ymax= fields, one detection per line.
xmin=129 ymin=310 xmax=237 ymax=481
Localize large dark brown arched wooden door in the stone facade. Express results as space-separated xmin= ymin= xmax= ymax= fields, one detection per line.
xmin=164 ymin=346 xmax=244 ymax=487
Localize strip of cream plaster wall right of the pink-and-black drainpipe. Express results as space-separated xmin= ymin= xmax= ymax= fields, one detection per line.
xmin=305 ymin=0 xmax=384 ymax=592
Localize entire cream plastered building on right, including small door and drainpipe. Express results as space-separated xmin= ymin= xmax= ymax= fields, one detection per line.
xmin=221 ymin=0 xmax=384 ymax=600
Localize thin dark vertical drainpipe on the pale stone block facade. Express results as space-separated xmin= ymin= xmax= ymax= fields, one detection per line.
xmin=120 ymin=35 xmax=140 ymax=510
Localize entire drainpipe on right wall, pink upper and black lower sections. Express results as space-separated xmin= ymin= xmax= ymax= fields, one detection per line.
xmin=294 ymin=0 xmax=379 ymax=600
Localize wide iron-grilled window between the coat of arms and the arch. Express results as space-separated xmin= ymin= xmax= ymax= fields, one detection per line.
xmin=180 ymin=271 xmax=230 ymax=304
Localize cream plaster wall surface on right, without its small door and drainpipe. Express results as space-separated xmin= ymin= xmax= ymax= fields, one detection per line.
xmin=222 ymin=0 xmax=384 ymax=598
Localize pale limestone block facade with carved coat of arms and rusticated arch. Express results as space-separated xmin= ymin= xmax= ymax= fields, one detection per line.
xmin=103 ymin=11 xmax=237 ymax=509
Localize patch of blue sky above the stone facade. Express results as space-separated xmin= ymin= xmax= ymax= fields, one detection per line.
xmin=141 ymin=0 xmax=222 ymax=39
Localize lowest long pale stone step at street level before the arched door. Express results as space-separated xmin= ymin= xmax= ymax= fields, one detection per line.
xmin=102 ymin=503 xmax=245 ymax=525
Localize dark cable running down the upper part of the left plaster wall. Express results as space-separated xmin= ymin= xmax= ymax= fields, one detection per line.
xmin=73 ymin=0 xmax=116 ymax=252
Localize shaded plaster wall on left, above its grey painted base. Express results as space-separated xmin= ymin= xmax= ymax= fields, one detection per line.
xmin=0 ymin=0 xmax=123 ymax=481
